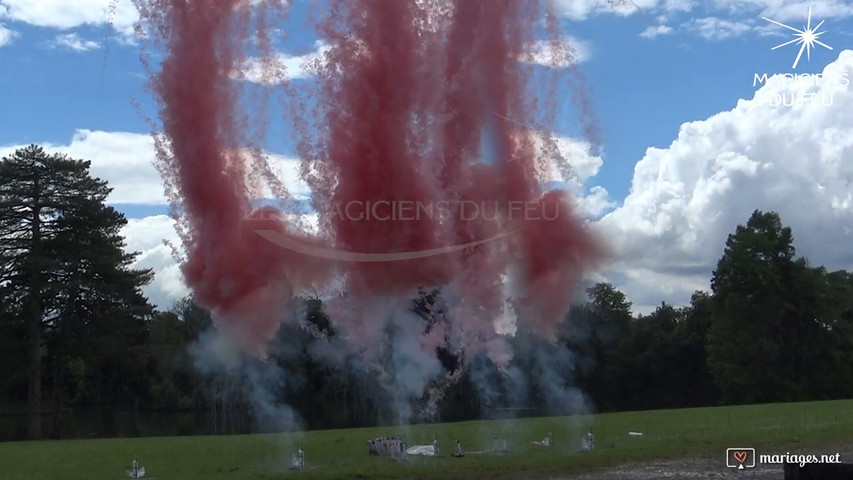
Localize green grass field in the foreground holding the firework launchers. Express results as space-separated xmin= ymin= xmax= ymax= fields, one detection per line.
xmin=0 ymin=400 xmax=853 ymax=480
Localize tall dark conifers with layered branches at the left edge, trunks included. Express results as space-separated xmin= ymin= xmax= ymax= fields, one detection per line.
xmin=0 ymin=145 xmax=153 ymax=438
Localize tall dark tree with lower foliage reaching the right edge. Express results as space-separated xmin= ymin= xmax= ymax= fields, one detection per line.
xmin=708 ymin=211 xmax=851 ymax=403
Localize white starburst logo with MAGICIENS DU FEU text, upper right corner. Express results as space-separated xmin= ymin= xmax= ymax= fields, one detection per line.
xmin=752 ymin=7 xmax=850 ymax=107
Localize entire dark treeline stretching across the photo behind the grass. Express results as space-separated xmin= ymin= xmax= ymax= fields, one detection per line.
xmin=5 ymin=145 xmax=853 ymax=438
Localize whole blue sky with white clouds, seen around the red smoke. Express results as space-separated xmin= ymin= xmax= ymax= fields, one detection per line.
xmin=0 ymin=0 xmax=853 ymax=313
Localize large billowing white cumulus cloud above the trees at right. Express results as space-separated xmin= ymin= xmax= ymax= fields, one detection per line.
xmin=596 ymin=51 xmax=853 ymax=311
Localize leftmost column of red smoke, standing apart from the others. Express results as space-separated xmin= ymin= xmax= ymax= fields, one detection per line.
xmin=137 ymin=0 xmax=327 ymax=355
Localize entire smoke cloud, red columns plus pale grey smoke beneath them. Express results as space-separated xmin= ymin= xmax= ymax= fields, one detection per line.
xmin=134 ymin=0 xmax=604 ymax=426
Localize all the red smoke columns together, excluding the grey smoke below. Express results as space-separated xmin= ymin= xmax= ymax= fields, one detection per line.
xmin=140 ymin=0 xmax=601 ymax=363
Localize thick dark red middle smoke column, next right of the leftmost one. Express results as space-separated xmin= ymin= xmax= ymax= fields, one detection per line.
xmin=312 ymin=1 xmax=452 ymax=296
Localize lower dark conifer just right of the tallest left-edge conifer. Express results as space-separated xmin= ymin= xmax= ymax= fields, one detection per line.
xmin=45 ymin=194 xmax=153 ymax=437
